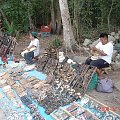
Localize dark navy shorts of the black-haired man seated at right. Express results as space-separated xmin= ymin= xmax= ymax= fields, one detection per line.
xmin=85 ymin=58 xmax=109 ymax=69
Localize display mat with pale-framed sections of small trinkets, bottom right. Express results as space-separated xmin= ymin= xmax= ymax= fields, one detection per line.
xmin=51 ymin=95 xmax=120 ymax=120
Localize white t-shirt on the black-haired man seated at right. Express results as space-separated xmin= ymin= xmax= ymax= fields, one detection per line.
xmin=96 ymin=42 xmax=113 ymax=64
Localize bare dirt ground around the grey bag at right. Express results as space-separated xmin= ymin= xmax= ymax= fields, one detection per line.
xmin=88 ymin=70 xmax=120 ymax=115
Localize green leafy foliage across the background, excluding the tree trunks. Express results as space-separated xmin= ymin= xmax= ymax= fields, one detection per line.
xmin=0 ymin=0 xmax=120 ymax=41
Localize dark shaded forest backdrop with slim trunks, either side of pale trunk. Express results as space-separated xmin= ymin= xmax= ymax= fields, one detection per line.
xmin=0 ymin=0 xmax=120 ymax=44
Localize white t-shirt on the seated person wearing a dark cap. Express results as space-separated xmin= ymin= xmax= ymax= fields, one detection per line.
xmin=27 ymin=38 xmax=40 ymax=57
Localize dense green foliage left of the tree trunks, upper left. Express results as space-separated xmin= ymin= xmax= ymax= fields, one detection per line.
xmin=0 ymin=0 xmax=50 ymax=32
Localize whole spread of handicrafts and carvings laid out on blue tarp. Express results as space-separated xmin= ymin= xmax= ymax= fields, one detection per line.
xmin=0 ymin=56 xmax=120 ymax=120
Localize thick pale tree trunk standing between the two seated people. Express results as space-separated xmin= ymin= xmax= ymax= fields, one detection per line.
xmin=59 ymin=0 xmax=76 ymax=52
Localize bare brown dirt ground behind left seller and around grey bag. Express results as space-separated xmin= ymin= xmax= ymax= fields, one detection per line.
xmin=15 ymin=35 xmax=120 ymax=115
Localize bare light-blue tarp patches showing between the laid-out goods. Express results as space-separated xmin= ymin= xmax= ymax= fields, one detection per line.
xmin=0 ymin=59 xmax=119 ymax=120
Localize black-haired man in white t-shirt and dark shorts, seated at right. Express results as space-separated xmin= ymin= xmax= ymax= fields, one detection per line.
xmin=85 ymin=33 xmax=113 ymax=78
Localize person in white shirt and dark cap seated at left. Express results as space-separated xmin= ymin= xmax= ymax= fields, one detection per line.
xmin=21 ymin=32 xmax=40 ymax=64
